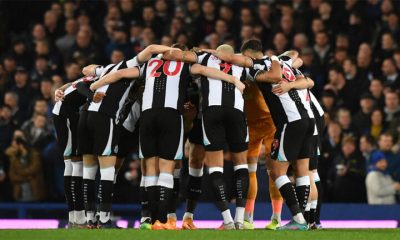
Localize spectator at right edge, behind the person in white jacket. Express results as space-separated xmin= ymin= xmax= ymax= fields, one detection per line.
xmin=378 ymin=133 xmax=400 ymax=181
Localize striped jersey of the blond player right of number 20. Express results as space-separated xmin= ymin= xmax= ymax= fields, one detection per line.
xmin=196 ymin=52 xmax=248 ymax=112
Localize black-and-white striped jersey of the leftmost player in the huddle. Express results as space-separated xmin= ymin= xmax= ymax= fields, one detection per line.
xmin=52 ymin=76 xmax=98 ymax=116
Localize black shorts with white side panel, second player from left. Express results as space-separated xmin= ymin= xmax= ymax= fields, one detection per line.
xmin=78 ymin=111 xmax=118 ymax=156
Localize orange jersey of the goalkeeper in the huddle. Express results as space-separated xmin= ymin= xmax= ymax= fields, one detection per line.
xmin=243 ymin=82 xmax=271 ymax=124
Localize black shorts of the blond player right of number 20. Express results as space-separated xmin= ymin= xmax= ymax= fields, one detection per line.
xmin=202 ymin=106 xmax=249 ymax=153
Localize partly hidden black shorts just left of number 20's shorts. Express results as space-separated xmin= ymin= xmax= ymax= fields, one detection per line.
xmin=116 ymin=126 xmax=139 ymax=158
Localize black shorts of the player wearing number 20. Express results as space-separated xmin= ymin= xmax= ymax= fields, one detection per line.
xmin=139 ymin=108 xmax=184 ymax=160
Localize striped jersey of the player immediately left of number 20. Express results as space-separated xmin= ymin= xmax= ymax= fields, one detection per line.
xmin=88 ymin=57 xmax=139 ymax=118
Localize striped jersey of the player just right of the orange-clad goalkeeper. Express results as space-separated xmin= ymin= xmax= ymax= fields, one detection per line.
xmin=250 ymin=57 xmax=314 ymax=128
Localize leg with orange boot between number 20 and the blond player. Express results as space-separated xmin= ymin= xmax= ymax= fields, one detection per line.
xmin=182 ymin=143 xmax=205 ymax=229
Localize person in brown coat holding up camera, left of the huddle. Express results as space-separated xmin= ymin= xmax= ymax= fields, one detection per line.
xmin=6 ymin=130 xmax=45 ymax=202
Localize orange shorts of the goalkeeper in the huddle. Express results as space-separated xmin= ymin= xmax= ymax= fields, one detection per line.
xmin=247 ymin=117 xmax=275 ymax=157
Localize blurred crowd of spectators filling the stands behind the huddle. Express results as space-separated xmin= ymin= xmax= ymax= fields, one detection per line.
xmin=0 ymin=0 xmax=400 ymax=204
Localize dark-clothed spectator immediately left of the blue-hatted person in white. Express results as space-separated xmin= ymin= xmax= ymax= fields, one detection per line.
xmin=334 ymin=136 xmax=366 ymax=202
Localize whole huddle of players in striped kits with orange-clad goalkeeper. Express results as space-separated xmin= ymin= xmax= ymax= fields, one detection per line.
xmin=53 ymin=40 xmax=324 ymax=230
